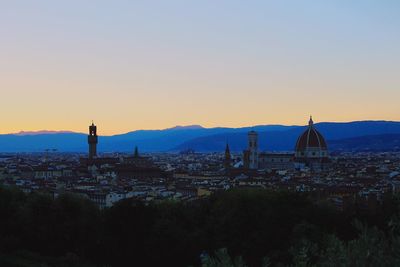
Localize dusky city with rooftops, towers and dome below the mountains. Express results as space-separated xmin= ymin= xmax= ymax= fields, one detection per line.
xmin=0 ymin=117 xmax=400 ymax=212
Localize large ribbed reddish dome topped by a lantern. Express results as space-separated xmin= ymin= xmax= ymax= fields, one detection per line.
xmin=296 ymin=118 xmax=328 ymax=152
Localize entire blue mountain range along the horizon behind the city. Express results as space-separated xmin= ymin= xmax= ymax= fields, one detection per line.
xmin=0 ymin=121 xmax=400 ymax=152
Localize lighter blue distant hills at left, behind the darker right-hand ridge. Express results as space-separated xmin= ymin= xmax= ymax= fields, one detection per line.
xmin=0 ymin=125 xmax=297 ymax=152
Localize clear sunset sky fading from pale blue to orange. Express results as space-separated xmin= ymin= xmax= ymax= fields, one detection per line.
xmin=0 ymin=0 xmax=400 ymax=134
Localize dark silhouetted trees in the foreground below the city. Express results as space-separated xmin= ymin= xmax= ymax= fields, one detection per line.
xmin=0 ymin=188 xmax=400 ymax=267
